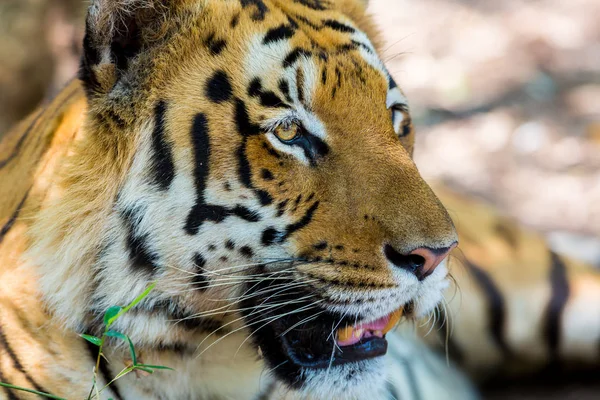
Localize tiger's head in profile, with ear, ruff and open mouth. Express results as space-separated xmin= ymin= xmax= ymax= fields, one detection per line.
xmin=32 ymin=0 xmax=457 ymax=398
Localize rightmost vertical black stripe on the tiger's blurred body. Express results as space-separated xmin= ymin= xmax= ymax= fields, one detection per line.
xmin=544 ymin=251 xmax=570 ymax=361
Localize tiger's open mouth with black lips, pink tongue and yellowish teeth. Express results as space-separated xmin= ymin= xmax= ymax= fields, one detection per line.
xmin=243 ymin=280 xmax=402 ymax=387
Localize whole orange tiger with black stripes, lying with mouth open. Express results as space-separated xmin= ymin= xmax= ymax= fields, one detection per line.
xmin=0 ymin=0 xmax=600 ymax=400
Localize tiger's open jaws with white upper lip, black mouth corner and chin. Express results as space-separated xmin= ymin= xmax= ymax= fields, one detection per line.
xmin=240 ymin=260 xmax=446 ymax=389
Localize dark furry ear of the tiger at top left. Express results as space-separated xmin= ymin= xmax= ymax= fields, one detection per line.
xmin=80 ymin=0 xmax=176 ymax=94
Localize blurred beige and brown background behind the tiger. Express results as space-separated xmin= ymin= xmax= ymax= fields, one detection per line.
xmin=0 ymin=0 xmax=600 ymax=399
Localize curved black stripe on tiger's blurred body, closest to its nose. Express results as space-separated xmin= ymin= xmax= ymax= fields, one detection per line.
xmin=465 ymin=260 xmax=512 ymax=355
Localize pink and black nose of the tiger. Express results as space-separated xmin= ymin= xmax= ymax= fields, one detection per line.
xmin=383 ymin=242 xmax=458 ymax=281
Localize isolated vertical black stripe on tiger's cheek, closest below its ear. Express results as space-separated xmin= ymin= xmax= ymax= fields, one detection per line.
xmin=150 ymin=101 xmax=175 ymax=191
